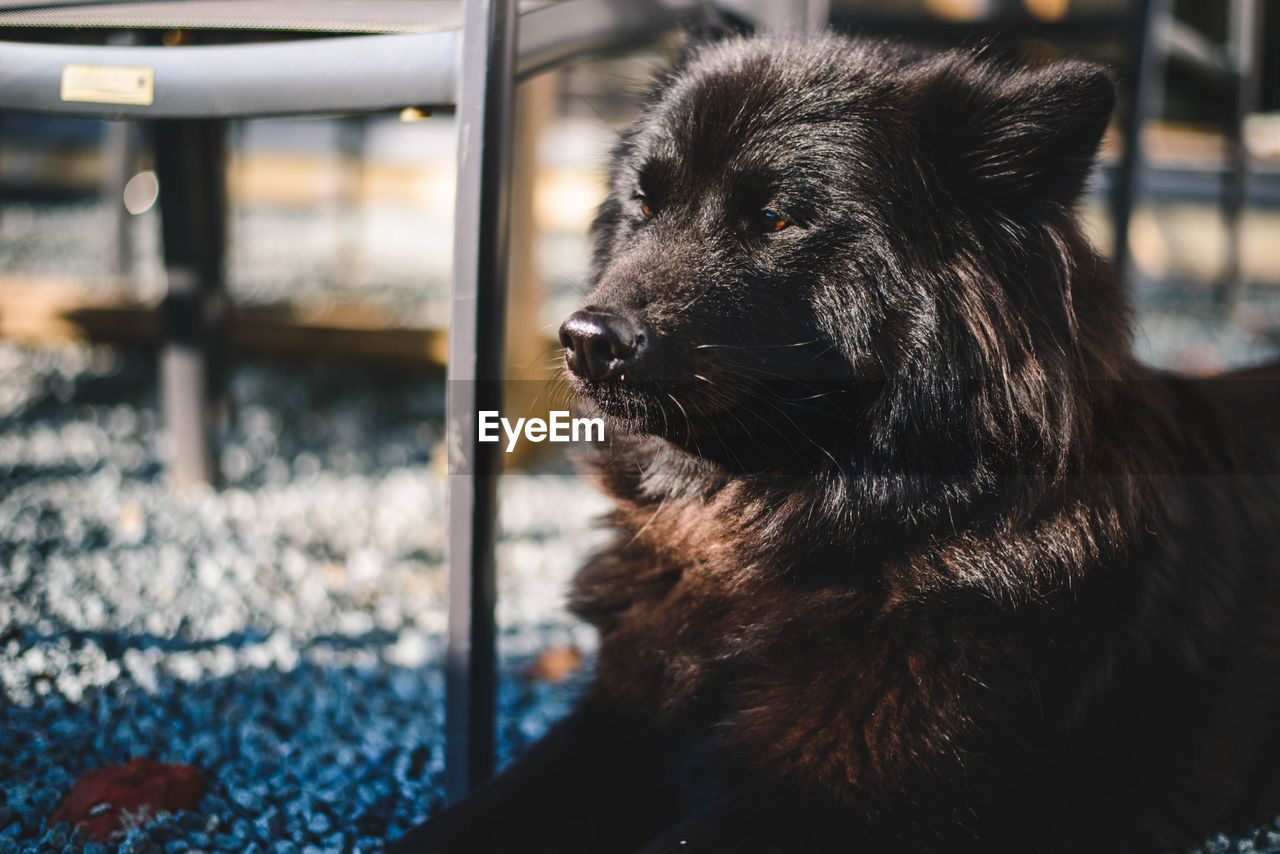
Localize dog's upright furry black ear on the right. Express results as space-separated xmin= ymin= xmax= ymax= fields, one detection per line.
xmin=911 ymin=55 xmax=1115 ymax=215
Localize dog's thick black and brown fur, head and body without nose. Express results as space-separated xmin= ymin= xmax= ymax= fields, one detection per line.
xmin=404 ymin=36 xmax=1280 ymax=854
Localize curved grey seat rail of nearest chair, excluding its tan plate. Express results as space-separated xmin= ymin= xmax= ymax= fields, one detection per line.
xmin=0 ymin=0 xmax=700 ymax=120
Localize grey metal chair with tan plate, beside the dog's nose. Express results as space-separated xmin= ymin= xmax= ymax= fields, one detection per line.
xmin=0 ymin=0 xmax=826 ymax=799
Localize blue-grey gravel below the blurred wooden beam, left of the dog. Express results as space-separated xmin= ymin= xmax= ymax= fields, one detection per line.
xmin=0 ymin=344 xmax=602 ymax=851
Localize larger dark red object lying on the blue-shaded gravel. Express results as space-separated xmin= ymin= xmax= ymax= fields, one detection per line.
xmin=50 ymin=757 xmax=205 ymax=842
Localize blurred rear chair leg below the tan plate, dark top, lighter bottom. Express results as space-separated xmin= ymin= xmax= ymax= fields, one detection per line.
xmin=154 ymin=120 xmax=227 ymax=487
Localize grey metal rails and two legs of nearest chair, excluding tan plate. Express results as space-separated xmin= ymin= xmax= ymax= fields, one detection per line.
xmin=0 ymin=0 xmax=727 ymax=799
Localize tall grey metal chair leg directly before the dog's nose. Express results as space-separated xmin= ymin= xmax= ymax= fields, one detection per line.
xmin=445 ymin=0 xmax=517 ymax=802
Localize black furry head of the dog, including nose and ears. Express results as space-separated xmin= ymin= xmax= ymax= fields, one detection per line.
xmin=561 ymin=36 xmax=1124 ymax=491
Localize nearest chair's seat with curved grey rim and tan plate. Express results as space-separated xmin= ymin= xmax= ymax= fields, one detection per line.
xmin=0 ymin=0 xmax=698 ymax=119
